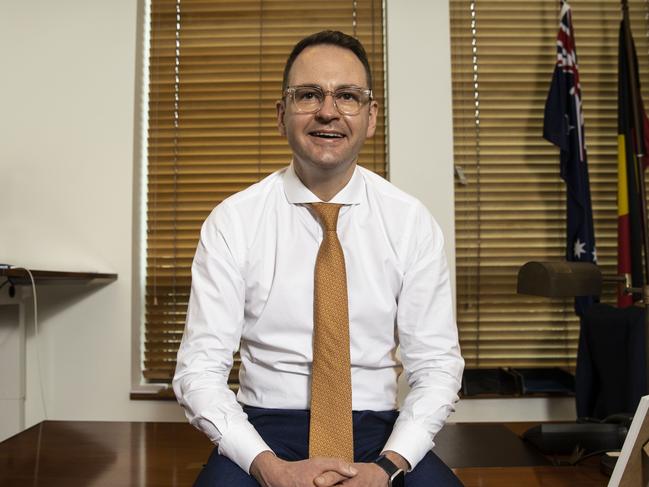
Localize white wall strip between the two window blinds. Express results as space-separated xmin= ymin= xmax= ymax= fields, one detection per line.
xmin=386 ymin=0 xmax=455 ymax=294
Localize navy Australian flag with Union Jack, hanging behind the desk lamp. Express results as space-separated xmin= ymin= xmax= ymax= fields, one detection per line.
xmin=543 ymin=2 xmax=597 ymax=316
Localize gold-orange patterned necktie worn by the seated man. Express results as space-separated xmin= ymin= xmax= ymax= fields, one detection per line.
xmin=309 ymin=203 xmax=354 ymax=462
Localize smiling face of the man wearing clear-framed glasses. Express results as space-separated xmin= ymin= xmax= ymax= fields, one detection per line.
xmin=277 ymin=45 xmax=378 ymax=178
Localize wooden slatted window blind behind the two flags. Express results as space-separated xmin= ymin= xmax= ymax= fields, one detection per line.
xmin=450 ymin=0 xmax=649 ymax=367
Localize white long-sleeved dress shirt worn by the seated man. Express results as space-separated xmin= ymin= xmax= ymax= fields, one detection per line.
xmin=173 ymin=165 xmax=464 ymax=472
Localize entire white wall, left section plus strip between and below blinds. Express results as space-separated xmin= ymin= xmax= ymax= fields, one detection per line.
xmin=0 ymin=0 xmax=576 ymax=434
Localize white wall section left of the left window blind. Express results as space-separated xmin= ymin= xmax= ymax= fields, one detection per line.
xmin=0 ymin=0 xmax=183 ymax=426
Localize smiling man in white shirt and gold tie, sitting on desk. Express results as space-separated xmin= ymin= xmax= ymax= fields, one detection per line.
xmin=173 ymin=31 xmax=464 ymax=487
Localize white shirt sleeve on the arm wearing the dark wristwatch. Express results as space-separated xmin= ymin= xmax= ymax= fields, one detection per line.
xmin=383 ymin=208 xmax=464 ymax=468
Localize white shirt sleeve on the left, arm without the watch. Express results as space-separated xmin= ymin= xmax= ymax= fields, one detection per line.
xmin=173 ymin=204 xmax=270 ymax=472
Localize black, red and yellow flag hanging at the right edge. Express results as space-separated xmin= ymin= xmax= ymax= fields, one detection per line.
xmin=617 ymin=20 xmax=649 ymax=308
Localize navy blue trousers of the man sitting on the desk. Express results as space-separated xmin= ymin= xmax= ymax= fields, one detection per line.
xmin=194 ymin=406 xmax=462 ymax=487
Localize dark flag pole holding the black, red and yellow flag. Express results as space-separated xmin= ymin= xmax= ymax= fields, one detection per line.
xmin=621 ymin=0 xmax=649 ymax=392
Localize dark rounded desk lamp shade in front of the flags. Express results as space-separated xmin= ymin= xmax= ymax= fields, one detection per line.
xmin=517 ymin=261 xmax=602 ymax=298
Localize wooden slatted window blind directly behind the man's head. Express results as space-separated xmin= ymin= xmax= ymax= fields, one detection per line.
xmin=143 ymin=0 xmax=387 ymax=387
